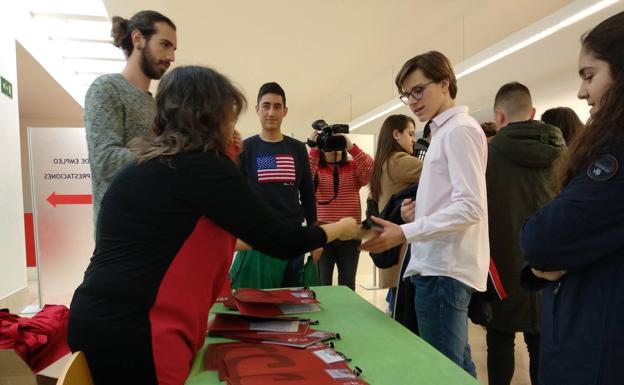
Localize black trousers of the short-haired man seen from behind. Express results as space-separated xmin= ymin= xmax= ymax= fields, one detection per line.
xmin=487 ymin=328 xmax=540 ymax=385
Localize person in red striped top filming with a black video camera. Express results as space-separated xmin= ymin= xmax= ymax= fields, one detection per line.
xmin=308 ymin=121 xmax=373 ymax=290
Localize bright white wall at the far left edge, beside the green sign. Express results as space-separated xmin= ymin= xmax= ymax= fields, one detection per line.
xmin=0 ymin=23 xmax=27 ymax=299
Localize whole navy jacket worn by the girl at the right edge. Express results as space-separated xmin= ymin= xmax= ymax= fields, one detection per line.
xmin=520 ymin=140 xmax=624 ymax=385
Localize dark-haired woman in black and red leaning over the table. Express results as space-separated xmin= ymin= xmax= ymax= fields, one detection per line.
xmin=69 ymin=66 xmax=359 ymax=385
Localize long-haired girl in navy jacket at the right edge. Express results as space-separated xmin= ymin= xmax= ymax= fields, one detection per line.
xmin=520 ymin=12 xmax=624 ymax=385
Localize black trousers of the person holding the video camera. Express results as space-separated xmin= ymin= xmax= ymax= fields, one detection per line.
xmin=319 ymin=240 xmax=360 ymax=290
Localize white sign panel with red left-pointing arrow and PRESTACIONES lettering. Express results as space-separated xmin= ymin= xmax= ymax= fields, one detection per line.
xmin=28 ymin=127 xmax=94 ymax=305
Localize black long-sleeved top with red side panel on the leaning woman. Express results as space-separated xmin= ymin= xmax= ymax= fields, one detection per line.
xmin=69 ymin=152 xmax=327 ymax=381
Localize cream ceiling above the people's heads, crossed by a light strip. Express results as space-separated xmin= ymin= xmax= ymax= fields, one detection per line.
xmin=18 ymin=0 xmax=624 ymax=138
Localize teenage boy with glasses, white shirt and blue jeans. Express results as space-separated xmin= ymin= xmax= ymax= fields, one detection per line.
xmin=362 ymin=51 xmax=490 ymax=377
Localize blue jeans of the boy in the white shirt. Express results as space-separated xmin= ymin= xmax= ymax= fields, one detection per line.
xmin=412 ymin=275 xmax=477 ymax=378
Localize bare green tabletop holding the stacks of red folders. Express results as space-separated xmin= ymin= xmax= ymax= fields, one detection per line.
xmin=186 ymin=286 xmax=478 ymax=385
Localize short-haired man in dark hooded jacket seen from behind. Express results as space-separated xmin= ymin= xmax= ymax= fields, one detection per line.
xmin=486 ymin=82 xmax=565 ymax=385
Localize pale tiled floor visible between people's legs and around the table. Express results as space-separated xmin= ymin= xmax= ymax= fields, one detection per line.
xmin=0 ymin=253 xmax=531 ymax=385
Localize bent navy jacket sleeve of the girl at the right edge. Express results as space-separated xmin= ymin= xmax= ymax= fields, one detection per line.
xmin=520 ymin=156 xmax=624 ymax=271
